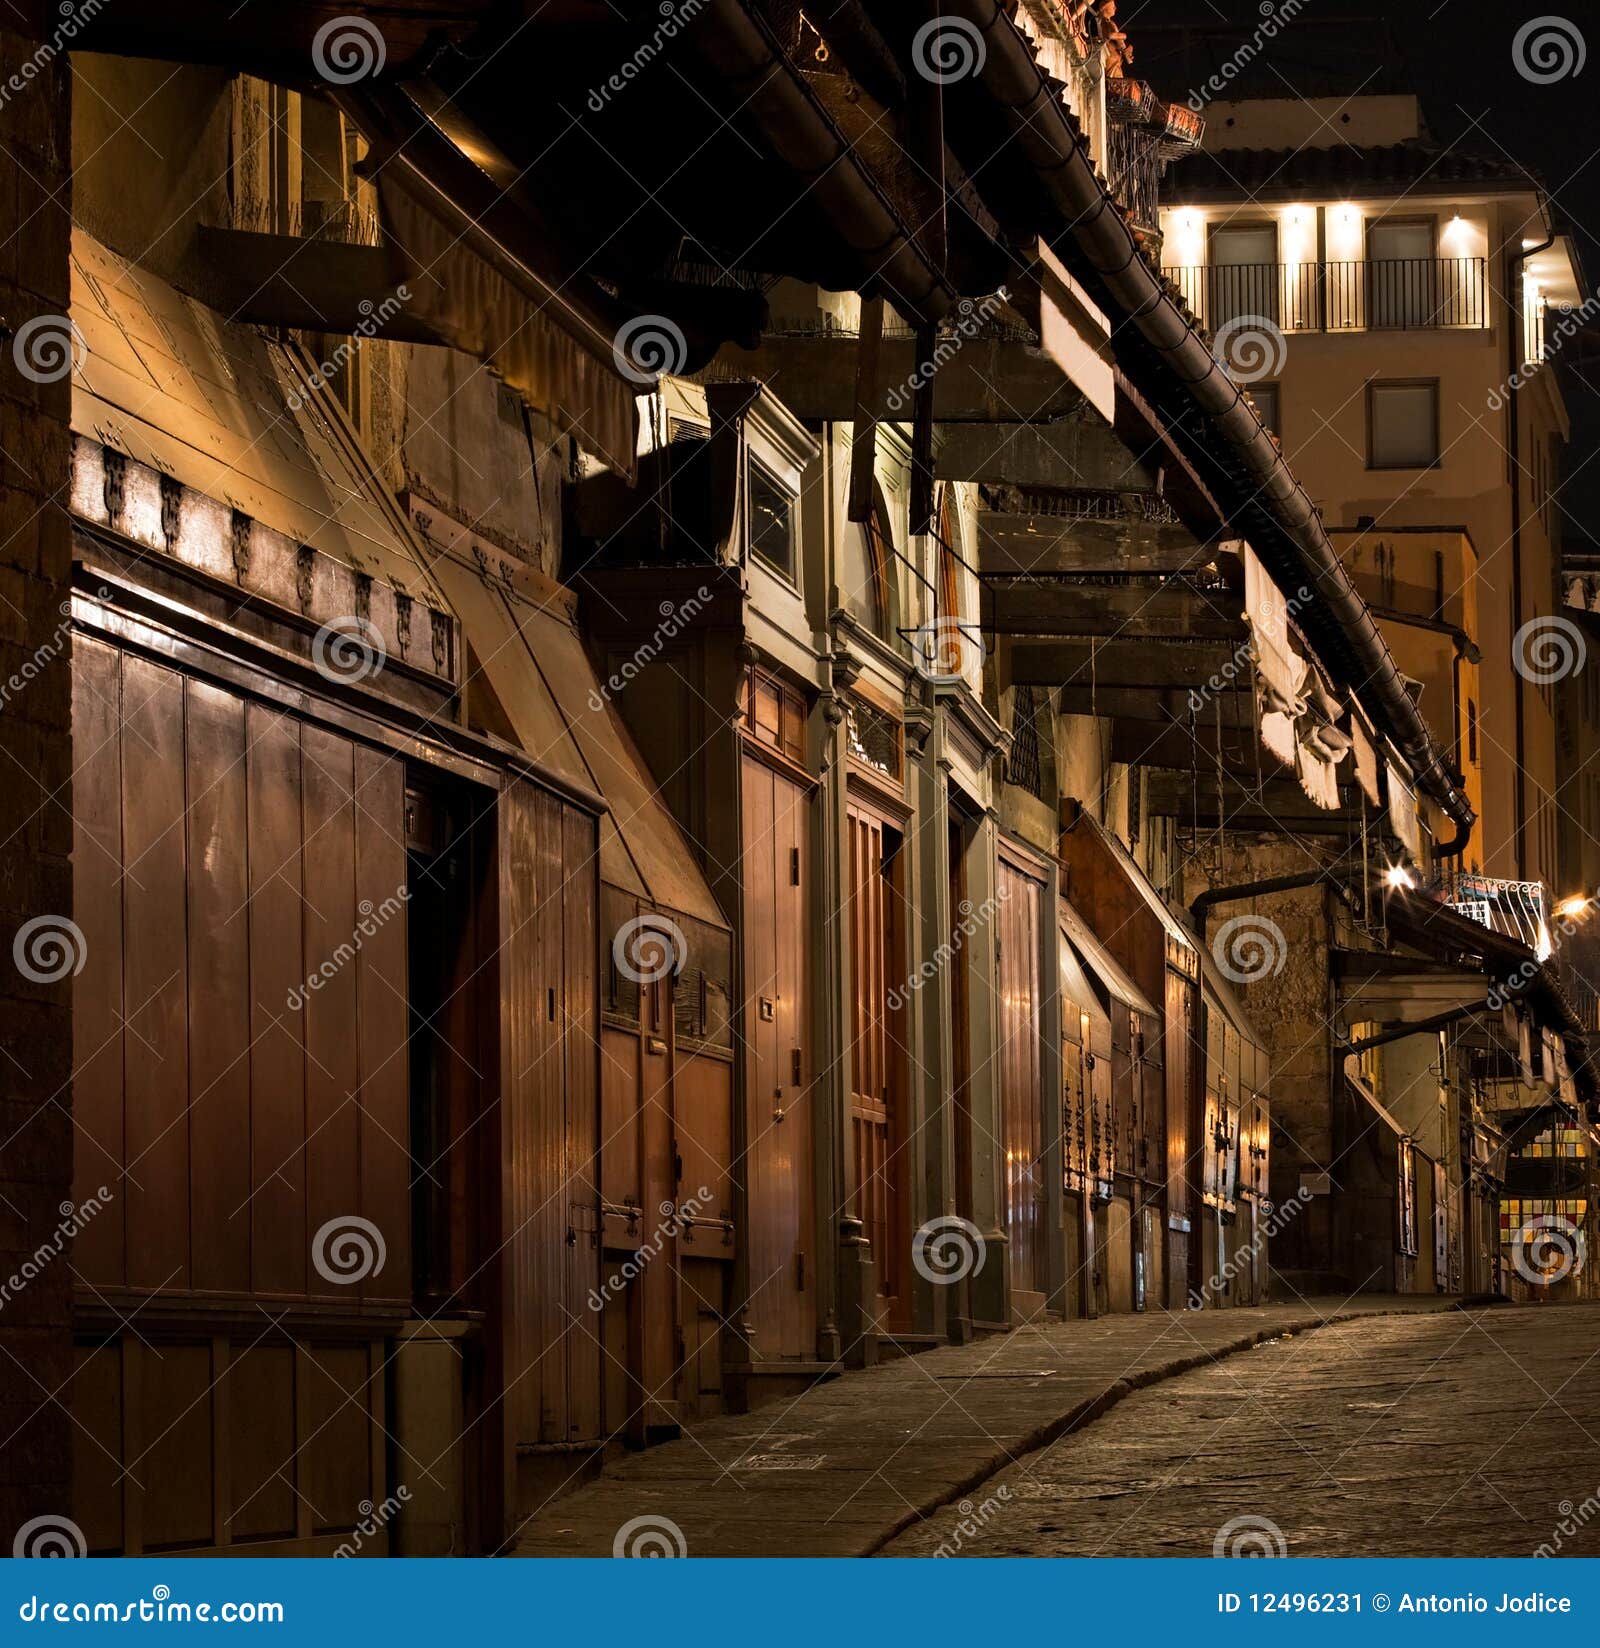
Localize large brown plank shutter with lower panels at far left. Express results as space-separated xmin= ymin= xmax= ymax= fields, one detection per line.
xmin=71 ymin=634 xmax=412 ymax=1554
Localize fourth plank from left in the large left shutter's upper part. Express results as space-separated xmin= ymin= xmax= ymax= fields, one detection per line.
xmin=246 ymin=704 xmax=311 ymax=1294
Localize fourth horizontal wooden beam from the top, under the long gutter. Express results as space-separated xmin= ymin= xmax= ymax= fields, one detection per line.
xmin=979 ymin=577 xmax=1246 ymax=644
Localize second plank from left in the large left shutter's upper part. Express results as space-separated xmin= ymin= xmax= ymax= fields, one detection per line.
xmin=122 ymin=658 xmax=189 ymax=1289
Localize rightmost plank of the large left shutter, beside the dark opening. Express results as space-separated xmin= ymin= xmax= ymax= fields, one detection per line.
xmin=354 ymin=747 xmax=410 ymax=1302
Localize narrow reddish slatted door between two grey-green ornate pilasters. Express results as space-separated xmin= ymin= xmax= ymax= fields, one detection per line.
xmin=845 ymin=806 xmax=905 ymax=1315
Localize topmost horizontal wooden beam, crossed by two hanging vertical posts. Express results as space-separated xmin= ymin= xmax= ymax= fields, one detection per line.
xmin=717 ymin=333 xmax=1083 ymax=425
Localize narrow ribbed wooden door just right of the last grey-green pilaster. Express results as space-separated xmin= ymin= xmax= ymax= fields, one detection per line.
xmin=997 ymin=860 xmax=1046 ymax=1294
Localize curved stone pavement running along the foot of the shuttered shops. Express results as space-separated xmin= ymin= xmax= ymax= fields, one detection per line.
xmin=516 ymin=1295 xmax=1465 ymax=1556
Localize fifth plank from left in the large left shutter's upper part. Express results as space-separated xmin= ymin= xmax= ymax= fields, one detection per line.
xmin=300 ymin=727 xmax=360 ymax=1299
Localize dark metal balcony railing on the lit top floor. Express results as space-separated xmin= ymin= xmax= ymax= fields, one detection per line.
xmin=1162 ymin=257 xmax=1490 ymax=333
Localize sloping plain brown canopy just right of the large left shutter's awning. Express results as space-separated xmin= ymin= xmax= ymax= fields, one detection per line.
xmin=430 ymin=530 xmax=727 ymax=926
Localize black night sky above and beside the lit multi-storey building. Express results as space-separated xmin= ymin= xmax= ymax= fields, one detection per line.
xmin=1117 ymin=0 xmax=1600 ymax=537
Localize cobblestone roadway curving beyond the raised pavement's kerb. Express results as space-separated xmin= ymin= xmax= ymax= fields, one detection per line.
xmin=883 ymin=1305 xmax=1600 ymax=1557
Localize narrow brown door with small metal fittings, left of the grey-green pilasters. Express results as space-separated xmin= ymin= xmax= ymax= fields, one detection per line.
xmin=743 ymin=755 xmax=817 ymax=1356
